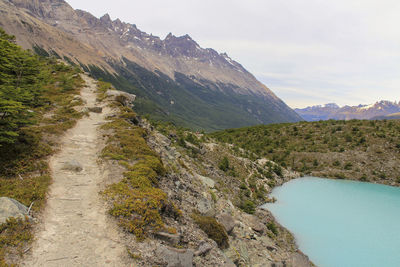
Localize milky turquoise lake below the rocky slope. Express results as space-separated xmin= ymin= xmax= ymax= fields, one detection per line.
xmin=264 ymin=177 xmax=400 ymax=267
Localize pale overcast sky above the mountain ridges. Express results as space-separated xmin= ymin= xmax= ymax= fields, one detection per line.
xmin=67 ymin=0 xmax=400 ymax=107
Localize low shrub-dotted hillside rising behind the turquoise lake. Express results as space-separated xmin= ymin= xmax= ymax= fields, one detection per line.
xmin=211 ymin=120 xmax=400 ymax=184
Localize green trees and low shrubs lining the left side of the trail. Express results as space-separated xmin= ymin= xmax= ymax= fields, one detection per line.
xmin=0 ymin=29 xmax=83 ymax=266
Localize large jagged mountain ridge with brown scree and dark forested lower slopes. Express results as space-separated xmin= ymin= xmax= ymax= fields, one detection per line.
xmin=0 ymin=0 xmax=301 ymax=131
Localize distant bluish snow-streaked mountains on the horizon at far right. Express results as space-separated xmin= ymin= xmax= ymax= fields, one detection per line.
xmin=295 ymin=101 xmax=400 ymax=121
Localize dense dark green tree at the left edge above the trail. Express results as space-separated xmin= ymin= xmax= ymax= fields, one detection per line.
xmin=0 ymin=28 xmax=42 ymax=146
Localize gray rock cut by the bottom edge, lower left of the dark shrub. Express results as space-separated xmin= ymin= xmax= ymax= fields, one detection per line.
xmin=156 ymin=247 xmax=194 ymax=267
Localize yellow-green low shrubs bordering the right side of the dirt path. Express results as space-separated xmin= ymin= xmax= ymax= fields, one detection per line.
xmin=99 ymin=83 xmax=180 ymax=240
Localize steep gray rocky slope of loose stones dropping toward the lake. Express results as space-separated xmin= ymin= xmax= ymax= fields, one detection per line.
xmin=134 ymin=122 xmax=311 ymax=266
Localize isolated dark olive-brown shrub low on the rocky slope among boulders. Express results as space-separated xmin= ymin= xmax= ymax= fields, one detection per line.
xmin=192 ymin=213 xmax=229 ymax=249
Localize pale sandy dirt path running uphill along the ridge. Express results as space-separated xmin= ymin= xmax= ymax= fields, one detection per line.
xmin=22 ymin=77 xmax=126 ymax=267
